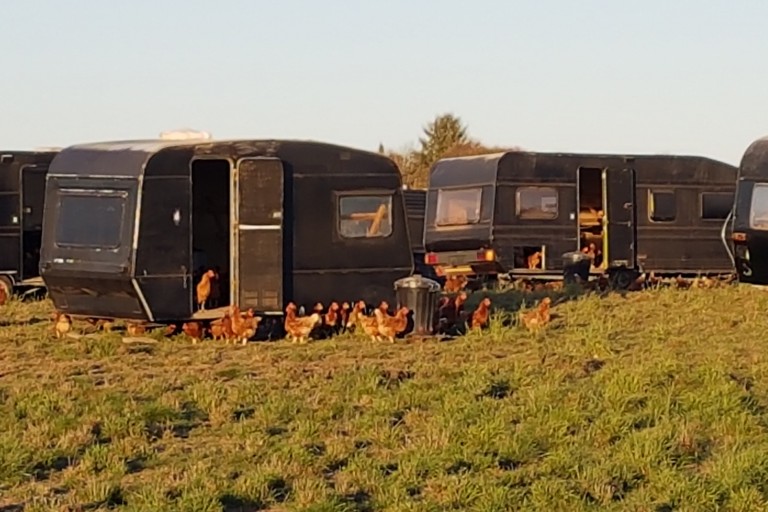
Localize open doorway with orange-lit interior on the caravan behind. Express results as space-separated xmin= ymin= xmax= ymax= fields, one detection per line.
xmin=578 ymin=167 xmax=605 ymax=268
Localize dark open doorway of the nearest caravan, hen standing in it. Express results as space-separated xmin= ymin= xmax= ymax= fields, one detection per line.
xmin=192 ymin=159 xmax=232 ymax=309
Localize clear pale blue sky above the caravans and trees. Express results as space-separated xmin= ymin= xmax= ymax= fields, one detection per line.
xmin=0 ymin=0 xmax=768 ymax=163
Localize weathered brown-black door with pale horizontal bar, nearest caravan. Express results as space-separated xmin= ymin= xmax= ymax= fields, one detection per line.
xmin=231 ymin=157 xmax=283 ymax=313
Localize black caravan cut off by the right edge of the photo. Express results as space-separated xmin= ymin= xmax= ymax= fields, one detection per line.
xmin=725 ymin=137 xmax=768 ymax=285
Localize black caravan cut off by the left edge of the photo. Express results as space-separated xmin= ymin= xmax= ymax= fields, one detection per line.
xmin=0 ymin=150 xmax=56 ymax=294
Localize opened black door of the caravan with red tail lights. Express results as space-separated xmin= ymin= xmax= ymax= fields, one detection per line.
xmin=603 ymin=169 xmax=637 ymax=269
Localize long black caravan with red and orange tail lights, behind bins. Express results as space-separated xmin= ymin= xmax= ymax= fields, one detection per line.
xmin=424 ymin=152 xmax=737 ymax=282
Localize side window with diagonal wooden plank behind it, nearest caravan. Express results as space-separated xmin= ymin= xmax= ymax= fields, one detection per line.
xmin=338 ymin=195 xmax=392 ymax=238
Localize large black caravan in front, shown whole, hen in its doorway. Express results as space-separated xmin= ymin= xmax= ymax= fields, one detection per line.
xmin=41 ymin=139 xmax=413 ymax=322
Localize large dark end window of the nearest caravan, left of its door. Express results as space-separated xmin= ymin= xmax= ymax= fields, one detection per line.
xmin=56 ymin=190 xmax=128 ymax=249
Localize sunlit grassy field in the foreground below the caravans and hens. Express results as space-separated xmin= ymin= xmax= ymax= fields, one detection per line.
xmin=0 ymin=286 xmax=768 ymax=512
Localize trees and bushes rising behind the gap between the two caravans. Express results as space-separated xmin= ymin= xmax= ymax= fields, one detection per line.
xmin=379 ymin=113 xmax=521 ymax=188
